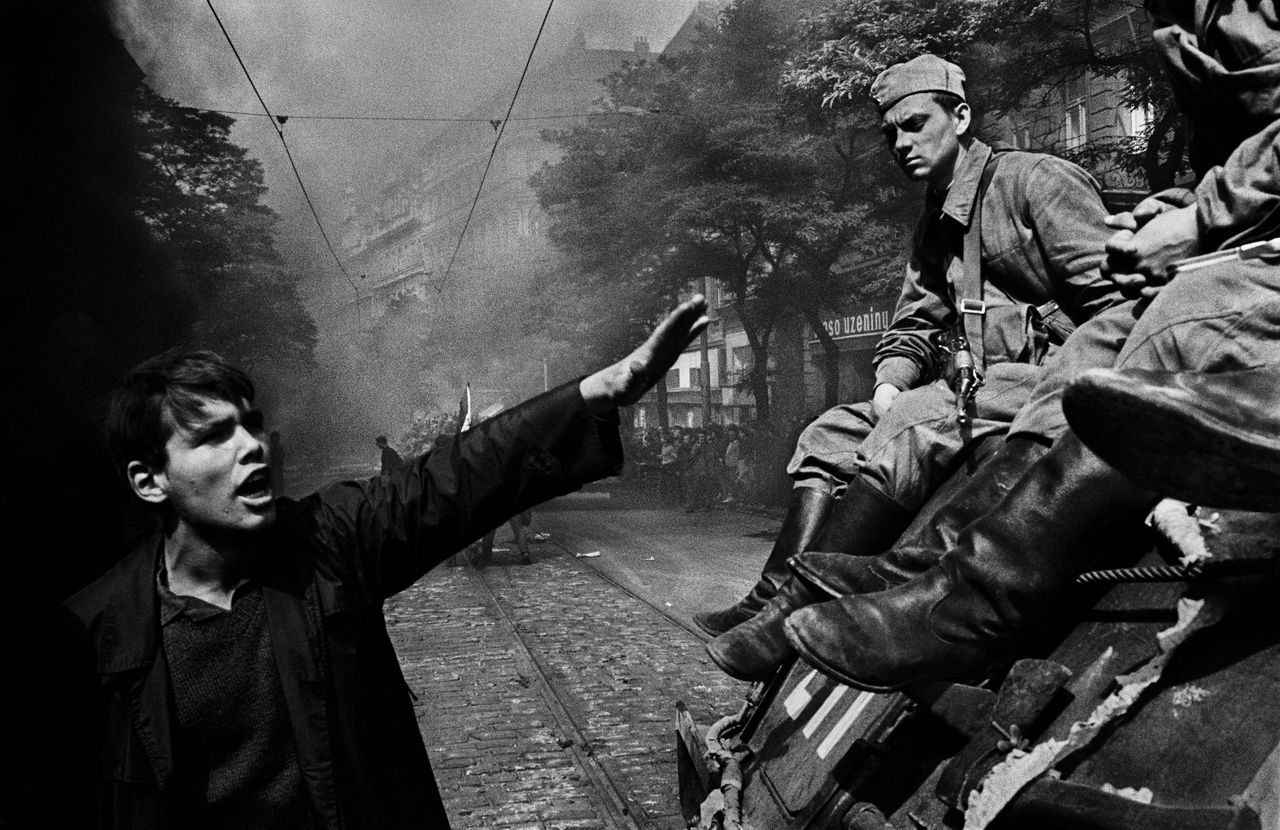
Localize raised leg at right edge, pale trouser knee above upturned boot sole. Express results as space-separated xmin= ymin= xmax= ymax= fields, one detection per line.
xmin=1066 ymin=258 xmax=1280 ymax=510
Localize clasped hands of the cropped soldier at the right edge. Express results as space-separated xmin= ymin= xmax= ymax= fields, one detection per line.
xmin=1102 ymin=206 xmax=1199 ymax=314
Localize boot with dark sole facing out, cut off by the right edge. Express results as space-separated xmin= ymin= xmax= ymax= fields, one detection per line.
xmin=1062 ymin=364 xmax=1280 ymax=512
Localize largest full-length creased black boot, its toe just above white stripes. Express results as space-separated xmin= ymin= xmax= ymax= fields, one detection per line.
xmin=783 ymin=433 xmax=1156 ymax=692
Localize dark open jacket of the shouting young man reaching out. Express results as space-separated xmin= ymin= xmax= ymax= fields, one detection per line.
xmin=67 ymin=384 xmax=622 ymax=829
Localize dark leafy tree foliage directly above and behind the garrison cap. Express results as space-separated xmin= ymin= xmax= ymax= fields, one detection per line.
xmin=786 ymin=0 xmax=1187 ymax=190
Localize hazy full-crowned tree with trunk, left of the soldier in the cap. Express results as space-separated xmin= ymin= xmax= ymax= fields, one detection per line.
xmin=534 ymin=0 xmax=916 ymax=419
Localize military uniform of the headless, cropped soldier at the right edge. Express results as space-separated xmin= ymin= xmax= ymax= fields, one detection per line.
xmin=1011 ymin=3 xmax=1280 ymax=438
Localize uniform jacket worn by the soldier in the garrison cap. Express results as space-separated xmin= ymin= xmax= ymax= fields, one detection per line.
xmin=873 ymin=140 xmax=1123 ymax=389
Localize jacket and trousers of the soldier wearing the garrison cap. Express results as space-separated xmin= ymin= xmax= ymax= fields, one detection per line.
xmin=787 ymin=140 xmax=1123 ymax=510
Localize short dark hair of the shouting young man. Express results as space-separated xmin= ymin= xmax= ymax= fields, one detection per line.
xmin=106 ymin=348 xmax=253 ymax=474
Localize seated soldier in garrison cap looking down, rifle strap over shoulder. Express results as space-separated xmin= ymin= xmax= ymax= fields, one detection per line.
xmin=698 ymin=55 xmax=1128 ymax=679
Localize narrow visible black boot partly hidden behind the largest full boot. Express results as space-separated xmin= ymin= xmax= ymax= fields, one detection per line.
xmin=791 ymin=435 xmax=1048 ymax=596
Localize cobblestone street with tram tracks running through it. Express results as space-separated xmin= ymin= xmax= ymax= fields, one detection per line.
xmin=387 ymin=502 xmax=769 ymax=830
